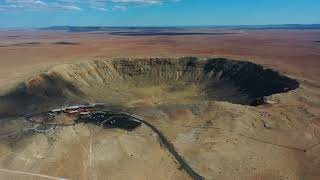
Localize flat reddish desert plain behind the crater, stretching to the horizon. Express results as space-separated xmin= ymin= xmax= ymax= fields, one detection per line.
xmin=0 ymin=30 xmax=320 ymax=87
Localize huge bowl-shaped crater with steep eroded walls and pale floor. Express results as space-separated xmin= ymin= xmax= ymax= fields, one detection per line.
xmin=0 ymin=57 xmax=299 ymax=116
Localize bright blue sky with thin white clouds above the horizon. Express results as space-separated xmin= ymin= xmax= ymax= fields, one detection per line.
xmin=0 ymin=0 xmax=320 ymax=28
